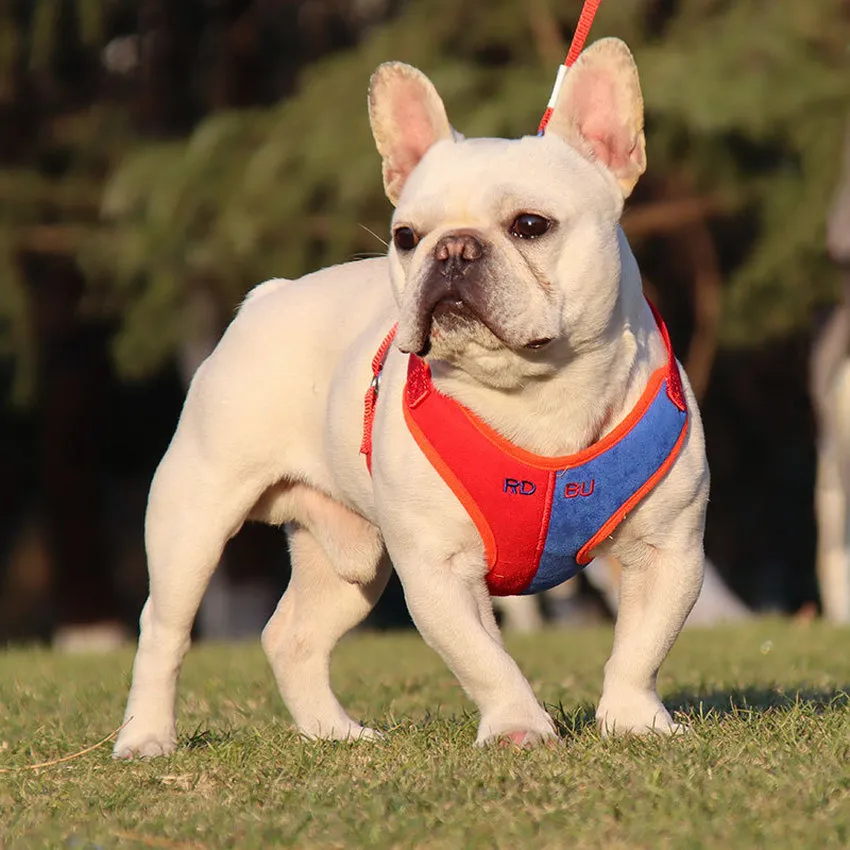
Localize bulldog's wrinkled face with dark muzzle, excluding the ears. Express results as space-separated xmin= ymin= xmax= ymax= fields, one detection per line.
xmin=390 ymin=137 xmax=621 ymax=358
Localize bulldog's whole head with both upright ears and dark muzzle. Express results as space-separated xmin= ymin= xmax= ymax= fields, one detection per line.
xmin=369 ymin=39 xmax=646 ymax=385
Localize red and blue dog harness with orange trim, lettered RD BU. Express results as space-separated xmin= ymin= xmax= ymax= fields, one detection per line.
xmin=361 ymin=304 xmax=688 ymax=596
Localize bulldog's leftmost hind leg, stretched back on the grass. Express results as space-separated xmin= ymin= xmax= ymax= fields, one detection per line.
xmin=113 ymin=435 xmax=262 ymax=759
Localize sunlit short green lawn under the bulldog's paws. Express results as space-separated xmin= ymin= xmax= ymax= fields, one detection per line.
xmin=0 ymin=620 xmax=850 ymax=850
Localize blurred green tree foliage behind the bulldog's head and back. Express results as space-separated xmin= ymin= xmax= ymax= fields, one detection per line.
xmin=0 ymin=0 xmax=850 ymax=398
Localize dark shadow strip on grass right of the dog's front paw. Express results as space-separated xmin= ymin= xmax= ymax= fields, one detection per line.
xmin=664 ymin=684 xmax=850 ymax=716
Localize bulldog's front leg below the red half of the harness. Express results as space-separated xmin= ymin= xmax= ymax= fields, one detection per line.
xmin=393 ymin=553 xmax=555 ymax=747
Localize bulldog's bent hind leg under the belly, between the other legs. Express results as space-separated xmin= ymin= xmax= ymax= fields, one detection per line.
xmin=263 ymin=516 xmax=390 ymax=739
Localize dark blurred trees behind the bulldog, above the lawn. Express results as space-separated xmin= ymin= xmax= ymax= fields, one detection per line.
xmin=0 ymin=0 xmax=850 ymax=637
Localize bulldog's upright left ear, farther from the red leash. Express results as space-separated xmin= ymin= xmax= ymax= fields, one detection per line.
xmin=369 ymin=62 xmax=453 ymax=204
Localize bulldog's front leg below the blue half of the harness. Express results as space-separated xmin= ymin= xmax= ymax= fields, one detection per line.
xmin=596 ymin=536 xmax=705 ymax=734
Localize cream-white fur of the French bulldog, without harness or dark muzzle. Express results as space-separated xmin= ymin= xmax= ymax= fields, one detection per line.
xmin=115 ymin=41 xmax=708 ymax=758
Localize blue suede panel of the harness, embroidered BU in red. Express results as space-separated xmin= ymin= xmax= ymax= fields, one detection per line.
xmin=523 ymin=381 xmax=687 ymax=594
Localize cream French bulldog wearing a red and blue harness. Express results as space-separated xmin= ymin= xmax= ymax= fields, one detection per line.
xmin=114 ymin=39 xmax=709 ymax=758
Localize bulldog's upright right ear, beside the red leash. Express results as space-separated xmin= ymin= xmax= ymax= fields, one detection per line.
xmin=546 ymin=38 xmax=646 ymax=198
